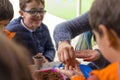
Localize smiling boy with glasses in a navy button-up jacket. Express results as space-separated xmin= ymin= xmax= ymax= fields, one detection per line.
xmin=6 ymin=0 xmax=55 ymax=62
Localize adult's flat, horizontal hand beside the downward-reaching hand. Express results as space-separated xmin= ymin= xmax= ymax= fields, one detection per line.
xmin=75 ymin=50 xmax=101 ymax=61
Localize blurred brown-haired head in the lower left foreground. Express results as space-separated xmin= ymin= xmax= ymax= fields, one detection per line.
xmin=0 ymin=32 xmax=32 ymax=80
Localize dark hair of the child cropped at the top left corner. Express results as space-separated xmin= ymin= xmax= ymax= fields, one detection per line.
xmin=0 ymin=0 xmax=14 ymax=21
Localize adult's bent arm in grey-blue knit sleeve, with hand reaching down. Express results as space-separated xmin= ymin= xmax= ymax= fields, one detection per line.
xmin=54 ymin=12 xmax=91 ymax=67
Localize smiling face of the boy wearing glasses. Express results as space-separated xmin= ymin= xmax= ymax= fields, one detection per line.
xmin=20 ymin=0 xmax=45 ymax=30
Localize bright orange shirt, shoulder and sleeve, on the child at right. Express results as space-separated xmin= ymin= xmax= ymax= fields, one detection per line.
xmin=71 ymin=62 xmax=120 ymax=80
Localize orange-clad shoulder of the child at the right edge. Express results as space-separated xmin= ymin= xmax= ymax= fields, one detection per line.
xmin=90 ymin=62 xmax=120 ymax=80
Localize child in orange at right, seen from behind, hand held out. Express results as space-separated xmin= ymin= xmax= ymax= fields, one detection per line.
xmin=57 ymin=0 xmax=120 ymax=80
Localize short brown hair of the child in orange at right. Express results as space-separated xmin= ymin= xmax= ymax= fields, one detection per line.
xmin=89 ymin=0 xmax=120 ymax=37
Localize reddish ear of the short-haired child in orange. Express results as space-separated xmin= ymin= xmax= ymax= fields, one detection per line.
xmin=99 ymin=25 xmax=118 ymax=48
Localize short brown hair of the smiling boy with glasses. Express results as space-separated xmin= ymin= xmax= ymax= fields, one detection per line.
xmin=19 ymin=0 xmax=45 ymax=10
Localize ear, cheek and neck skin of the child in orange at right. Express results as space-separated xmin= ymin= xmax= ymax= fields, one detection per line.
xmin=94 ymin=25 xmax=120 ymax=62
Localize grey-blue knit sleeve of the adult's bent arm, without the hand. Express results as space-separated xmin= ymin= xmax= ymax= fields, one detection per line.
xmin=54 ymin=12 xmax=91 ymax=47
